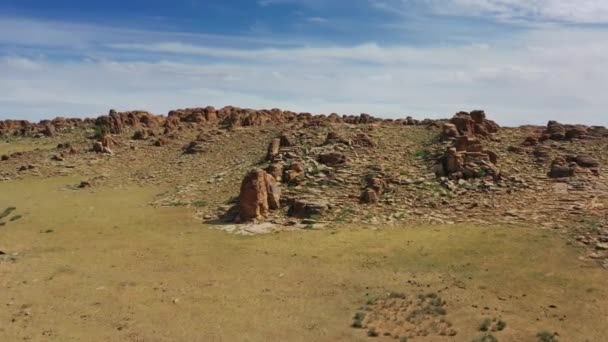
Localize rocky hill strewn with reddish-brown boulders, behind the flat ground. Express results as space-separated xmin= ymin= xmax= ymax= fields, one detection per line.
xmin=0 ymin=107 xmax=608 ymax=267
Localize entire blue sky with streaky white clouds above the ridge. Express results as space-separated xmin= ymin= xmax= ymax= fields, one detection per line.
xmin=0 ymin=0 xmax=608 ymax=125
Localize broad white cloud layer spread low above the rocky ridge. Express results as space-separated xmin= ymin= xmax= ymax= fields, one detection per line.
xmin=0 ymin=16 xmax=608 ymax=125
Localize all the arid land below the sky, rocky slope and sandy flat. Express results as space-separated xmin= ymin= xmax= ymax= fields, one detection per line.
xmin=0 ymin=107 xmax=608 ymax=342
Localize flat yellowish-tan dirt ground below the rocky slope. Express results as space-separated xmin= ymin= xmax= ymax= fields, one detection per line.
xmin=0 ymin=177 xmax=608 ymax=342
